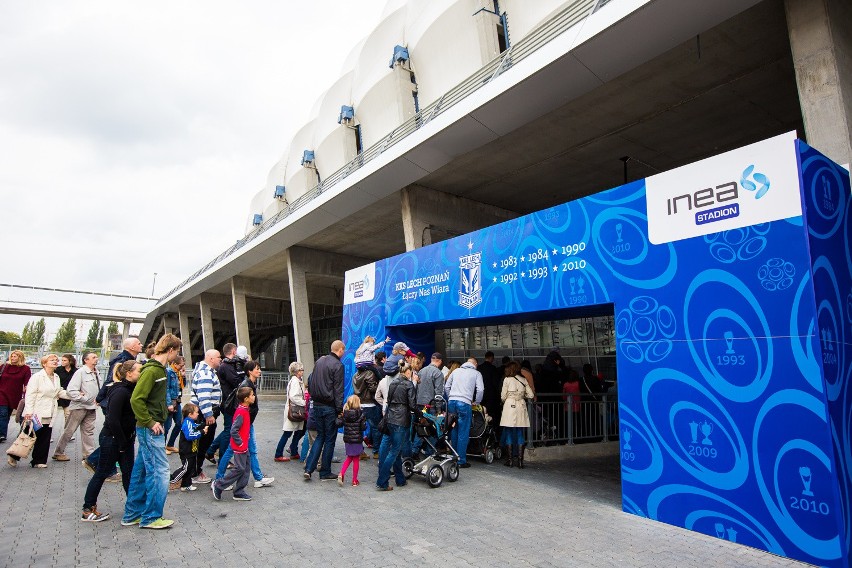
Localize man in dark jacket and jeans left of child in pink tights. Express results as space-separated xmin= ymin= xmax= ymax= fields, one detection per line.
xmin=305 ymin=339 xmax=346 ymax=481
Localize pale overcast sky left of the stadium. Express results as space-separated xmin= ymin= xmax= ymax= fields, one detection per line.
xmin=0 ymin=0 xmax=384 ymax=342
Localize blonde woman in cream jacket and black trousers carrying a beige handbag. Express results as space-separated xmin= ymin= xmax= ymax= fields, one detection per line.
xmin=8 ymin=353 xmax=70 ymax=468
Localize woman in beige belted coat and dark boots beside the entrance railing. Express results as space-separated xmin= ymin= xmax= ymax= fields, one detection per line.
xmin=500 ymin=361 xmax=535 ymax=469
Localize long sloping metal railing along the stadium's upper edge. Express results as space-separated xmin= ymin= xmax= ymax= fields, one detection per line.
xmin=160 ymin=0 xmax=597 ymax=301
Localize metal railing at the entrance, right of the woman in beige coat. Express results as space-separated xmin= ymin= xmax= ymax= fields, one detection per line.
xmin=527 ymin=393 xmax=619 ymax=446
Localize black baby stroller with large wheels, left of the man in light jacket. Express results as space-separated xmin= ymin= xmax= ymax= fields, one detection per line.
xmin=402 ymin=395 xmax=459 ymax=487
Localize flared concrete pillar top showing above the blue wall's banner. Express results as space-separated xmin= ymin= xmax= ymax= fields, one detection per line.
xmin=400 ymin=185 xmax=518 ymax=251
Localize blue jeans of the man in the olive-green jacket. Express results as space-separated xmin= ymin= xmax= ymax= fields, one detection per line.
xmin=123 ymin=426 xmax=169 ymax=525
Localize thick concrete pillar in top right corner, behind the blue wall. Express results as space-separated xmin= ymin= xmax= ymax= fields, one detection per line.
xmin=784 ymin=0 xmax=852 ymax=164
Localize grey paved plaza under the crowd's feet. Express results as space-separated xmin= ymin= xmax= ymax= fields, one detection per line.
xmin=0 ymin=400 xmax=803 ymax=568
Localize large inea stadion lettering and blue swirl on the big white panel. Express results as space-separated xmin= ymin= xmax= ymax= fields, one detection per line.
xmin=666 ymin=164 xmax=770 ymax=225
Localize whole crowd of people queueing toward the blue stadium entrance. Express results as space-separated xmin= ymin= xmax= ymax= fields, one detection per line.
xmin=0 ymin=334 xmax=602 ymax=529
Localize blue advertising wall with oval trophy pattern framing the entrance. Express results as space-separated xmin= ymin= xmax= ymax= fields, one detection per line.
xmin=343 ymin=135 xmax=852 ymax=566
